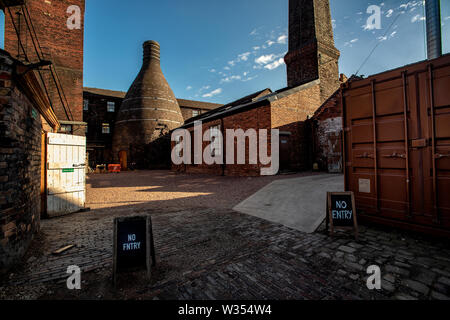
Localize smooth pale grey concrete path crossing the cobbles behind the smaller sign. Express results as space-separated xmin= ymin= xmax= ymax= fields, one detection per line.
xmin=233 ymin=174 xmax=344 ymax=233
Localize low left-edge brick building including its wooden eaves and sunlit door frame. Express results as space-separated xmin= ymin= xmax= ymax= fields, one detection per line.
xmin=0 ymin=50 xmax=59 ymax=273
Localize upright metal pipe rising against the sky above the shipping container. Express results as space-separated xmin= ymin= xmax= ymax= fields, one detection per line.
xmin=425 ymin=0 xmax=442 ymax=60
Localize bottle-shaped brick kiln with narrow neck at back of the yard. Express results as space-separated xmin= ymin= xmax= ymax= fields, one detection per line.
xmin=113 ymin=41 xmax=184 ymax=169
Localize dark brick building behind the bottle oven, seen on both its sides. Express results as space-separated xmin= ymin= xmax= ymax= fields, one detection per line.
xmin=83 ymin=88 xmax=221 ymax=168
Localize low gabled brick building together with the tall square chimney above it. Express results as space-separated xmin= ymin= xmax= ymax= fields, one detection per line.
xmin=173 ymin=0 xmax=341 ymax=176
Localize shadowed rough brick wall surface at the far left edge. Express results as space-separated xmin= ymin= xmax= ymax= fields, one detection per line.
xmin=0 ymin=55 xmax=42 ymax=271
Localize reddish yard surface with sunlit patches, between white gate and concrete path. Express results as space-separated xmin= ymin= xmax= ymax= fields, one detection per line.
xmin=87 ymin=171 xmax=311 ymax=209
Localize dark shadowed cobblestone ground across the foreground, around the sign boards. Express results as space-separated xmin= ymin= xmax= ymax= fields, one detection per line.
xmin=0 ymin=171 xmax=450 ymax=299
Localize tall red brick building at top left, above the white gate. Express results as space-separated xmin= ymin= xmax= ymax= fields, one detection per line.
xmin=4 ymin=0 xmax=85 ymax=135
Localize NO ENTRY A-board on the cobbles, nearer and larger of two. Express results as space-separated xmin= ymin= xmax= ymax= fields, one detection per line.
xmin=113 ymin=216 xmax=156 ymax=283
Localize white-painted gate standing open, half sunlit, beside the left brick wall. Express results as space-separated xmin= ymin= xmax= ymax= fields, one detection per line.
xmin=47 ymin=133 xmax=86 ymax=217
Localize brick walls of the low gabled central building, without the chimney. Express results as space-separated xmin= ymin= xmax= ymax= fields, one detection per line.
xmin=172 ymin=81 xmax=320 ymax=176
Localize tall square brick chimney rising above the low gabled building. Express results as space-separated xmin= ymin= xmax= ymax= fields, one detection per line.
xmin=284 ymin=0 xmax=340 ymax=102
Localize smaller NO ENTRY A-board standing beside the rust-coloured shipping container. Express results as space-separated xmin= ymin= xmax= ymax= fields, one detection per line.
xmin=327 ymin=192 xmax=358 ymax=238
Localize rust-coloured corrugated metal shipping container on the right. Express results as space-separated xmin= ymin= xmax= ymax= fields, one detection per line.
xmin=341 ymin=55 xmax=450 ymax=236
